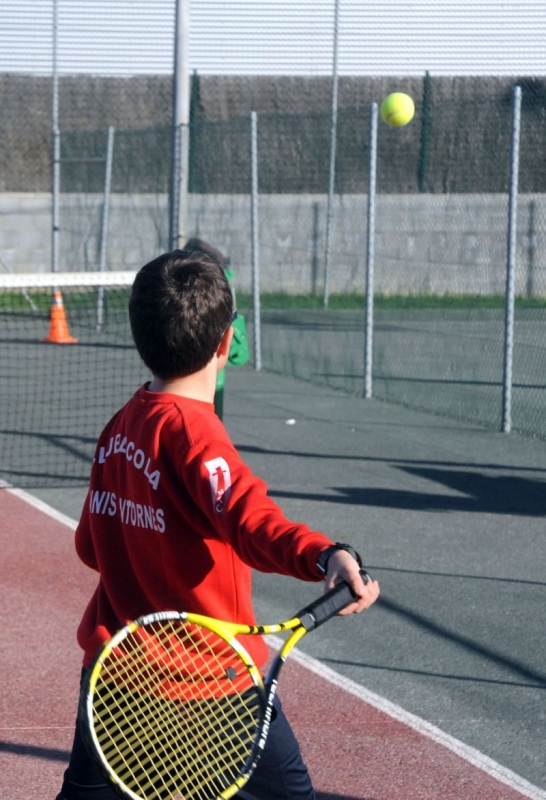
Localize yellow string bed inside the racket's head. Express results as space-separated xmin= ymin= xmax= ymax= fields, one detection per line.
xmin=93 ymin=620 xmax=263 ymax=800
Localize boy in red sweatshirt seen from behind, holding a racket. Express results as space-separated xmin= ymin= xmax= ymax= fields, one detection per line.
xmin=57 ymin=251 xmax=379 ymax=800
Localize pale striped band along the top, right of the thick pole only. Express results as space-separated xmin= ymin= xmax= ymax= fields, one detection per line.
xmin=191 ymin=0 xmax=546 ymax=75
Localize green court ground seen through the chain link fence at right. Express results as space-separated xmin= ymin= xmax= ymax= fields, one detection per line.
xmin=251 ymin=298 xmax=546 ymax=437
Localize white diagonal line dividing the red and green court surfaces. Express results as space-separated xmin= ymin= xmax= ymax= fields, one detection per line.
xmin=5 ymin=482 xmax=546 ymax=800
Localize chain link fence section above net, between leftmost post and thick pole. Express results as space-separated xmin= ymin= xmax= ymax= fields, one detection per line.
xmin=58 ymin=126 xmax=170 ymax=272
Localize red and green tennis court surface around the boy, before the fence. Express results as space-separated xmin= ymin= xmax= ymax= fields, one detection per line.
xmin=0 ymin=369 xmax=546 ymax=800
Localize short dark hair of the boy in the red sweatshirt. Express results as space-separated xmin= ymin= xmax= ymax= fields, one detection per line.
xmin=129 ymin=250 xmax=233 ymax=380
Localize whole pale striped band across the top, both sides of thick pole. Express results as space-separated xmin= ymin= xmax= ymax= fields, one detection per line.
xmin=0 ymin=0 xmax=546 ymax=75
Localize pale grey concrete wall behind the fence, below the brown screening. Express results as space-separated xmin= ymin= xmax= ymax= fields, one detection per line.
xmin=0 ymin=193 xmax=546 ymax=296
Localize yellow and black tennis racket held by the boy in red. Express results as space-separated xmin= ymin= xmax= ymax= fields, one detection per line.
xmin=80 ymin=570 xmax=370 ymax=800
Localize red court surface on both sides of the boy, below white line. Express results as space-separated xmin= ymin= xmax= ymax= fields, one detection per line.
xmin=0 ymin=489 xmax=546 ymax=800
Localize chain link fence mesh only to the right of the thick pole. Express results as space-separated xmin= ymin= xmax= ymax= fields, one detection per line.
xmin=186 ymin=91 xmax=546 ymax=444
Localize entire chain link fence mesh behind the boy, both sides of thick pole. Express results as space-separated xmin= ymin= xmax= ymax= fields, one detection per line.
xmin=0 ymin=78 xmax=546 ymax=466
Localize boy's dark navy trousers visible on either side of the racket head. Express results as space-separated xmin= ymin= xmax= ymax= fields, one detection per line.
xmin=57 ymin=668 xmax=315 ymax=800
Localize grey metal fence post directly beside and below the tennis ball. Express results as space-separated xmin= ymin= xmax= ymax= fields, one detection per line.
xmin=364 ymin=103 xmax=379 ymax=400
